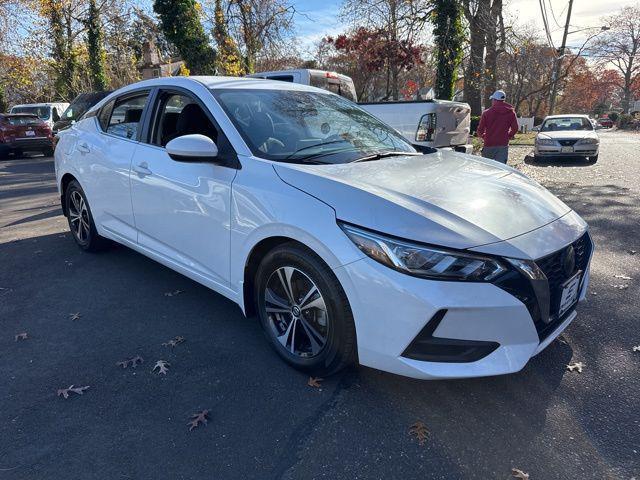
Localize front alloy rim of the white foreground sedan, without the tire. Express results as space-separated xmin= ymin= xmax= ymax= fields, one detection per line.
xmin=264 ymin=266 xmax=330 ymax=358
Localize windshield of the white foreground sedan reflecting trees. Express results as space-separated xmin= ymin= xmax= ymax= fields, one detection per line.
xmin=212 ymin=89 xmax=416 ymax=163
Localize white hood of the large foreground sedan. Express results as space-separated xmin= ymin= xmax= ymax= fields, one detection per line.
xmin=274 ymin=151 xmax=571 ymax=249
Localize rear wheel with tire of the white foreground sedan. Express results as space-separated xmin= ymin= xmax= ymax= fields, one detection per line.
xmin=64 ymin=180 xmax=109 ymax=252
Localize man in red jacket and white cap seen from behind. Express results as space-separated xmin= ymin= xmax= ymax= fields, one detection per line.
xmin=476 ymin=90 xmax=518 ymax=163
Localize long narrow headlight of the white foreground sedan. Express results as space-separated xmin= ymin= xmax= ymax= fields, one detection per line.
xmin=339 ymin=223 xmax=507 ymax=282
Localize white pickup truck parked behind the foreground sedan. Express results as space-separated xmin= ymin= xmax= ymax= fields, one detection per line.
xmin=249 ymin=69 xmax=473 ymax=153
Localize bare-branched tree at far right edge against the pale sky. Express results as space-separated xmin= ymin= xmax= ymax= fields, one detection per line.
xmin=591 ymin=6 xmax=640 ymax=113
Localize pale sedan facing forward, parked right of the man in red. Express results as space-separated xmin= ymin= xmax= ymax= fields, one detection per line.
xmin=534 ymin=115 xmax=600 ymax=162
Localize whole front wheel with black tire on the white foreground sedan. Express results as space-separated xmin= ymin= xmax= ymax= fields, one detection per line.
xmin=254 ymin=242 xmax=356 ymax=377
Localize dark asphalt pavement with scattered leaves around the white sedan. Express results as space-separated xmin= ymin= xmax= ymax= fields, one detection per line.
xmin=0 ymin=128 xmax=640 ymax=480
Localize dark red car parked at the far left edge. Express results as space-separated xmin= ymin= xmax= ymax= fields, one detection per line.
xmin=0 ymin=113 xmax=53 ymax=158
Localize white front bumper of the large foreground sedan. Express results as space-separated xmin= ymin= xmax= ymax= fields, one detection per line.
xmin=334 ymin=235 xmax=589 ymax=379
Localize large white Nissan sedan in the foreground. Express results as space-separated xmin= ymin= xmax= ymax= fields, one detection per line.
xmin=55 ymin=77 xmax=592 ymax=379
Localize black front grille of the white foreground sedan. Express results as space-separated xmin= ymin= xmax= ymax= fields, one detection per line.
xmin=536 ymin=233 xmax=593 ymax=340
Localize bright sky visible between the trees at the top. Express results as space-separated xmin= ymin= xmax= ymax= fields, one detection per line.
xmin=293 ymin=0 xmax=639 ymax=53
